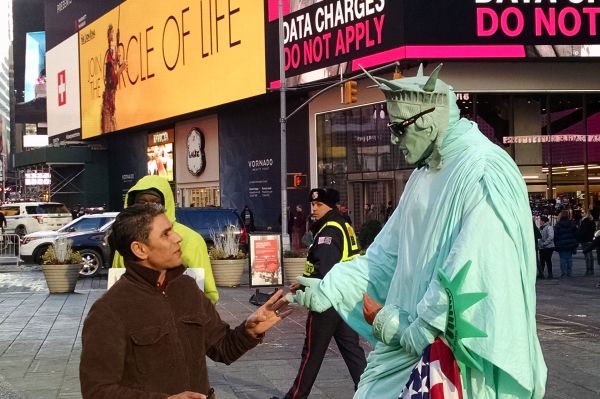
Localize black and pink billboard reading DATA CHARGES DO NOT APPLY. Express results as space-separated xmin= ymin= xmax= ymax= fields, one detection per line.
xmin=266 ymin=0 xmax=600 ymax=87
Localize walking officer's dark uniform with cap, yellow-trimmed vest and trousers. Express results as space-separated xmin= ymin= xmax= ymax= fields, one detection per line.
xmin=285 ymin=189 xmax=367 ymax=399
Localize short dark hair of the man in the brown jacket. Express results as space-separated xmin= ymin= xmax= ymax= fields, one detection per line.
xmin=109 ymin=202 xmax=165 ymax=260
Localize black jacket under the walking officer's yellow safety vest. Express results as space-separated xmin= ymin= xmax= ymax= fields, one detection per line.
xmin=307 ymin=209 xmax=346 ymax=278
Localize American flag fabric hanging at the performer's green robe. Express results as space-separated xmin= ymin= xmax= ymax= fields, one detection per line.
xmin=400 ymin=338 xmax=463 ymax=399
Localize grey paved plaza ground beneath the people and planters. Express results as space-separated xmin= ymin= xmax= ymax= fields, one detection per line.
xmin=0 ymin=254 xmax=600 ymax=399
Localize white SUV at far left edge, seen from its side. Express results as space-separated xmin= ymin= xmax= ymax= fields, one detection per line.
xmin=0 ymin=202 xmax=73 ymax=237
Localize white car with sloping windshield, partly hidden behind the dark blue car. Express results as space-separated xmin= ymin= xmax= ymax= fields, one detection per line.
xmin=21 ymin=212 xmax=119 ymax=264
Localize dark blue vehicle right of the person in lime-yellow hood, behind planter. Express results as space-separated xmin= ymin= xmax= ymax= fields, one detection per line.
xmin=175 ymin=207 xmax=248 ymax=247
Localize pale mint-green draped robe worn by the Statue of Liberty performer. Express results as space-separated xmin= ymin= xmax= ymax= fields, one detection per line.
xmin=320 ymin=119 xmax=547 ymax=399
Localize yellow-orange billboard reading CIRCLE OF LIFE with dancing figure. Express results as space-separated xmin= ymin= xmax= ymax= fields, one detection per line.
xmin=79 ymin=0 xmax=266 ymax=138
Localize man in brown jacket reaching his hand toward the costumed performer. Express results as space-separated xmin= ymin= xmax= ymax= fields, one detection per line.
xmin=79 ymin=203 xmax=291 ymax=399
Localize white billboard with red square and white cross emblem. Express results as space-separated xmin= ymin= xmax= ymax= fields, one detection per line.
xmin=46 ymin=35 xmax=81 ymax=137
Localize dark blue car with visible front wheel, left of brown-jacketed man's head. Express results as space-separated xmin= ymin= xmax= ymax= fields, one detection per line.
xmin=64 ymin=219 xmax=115 ymax=277
